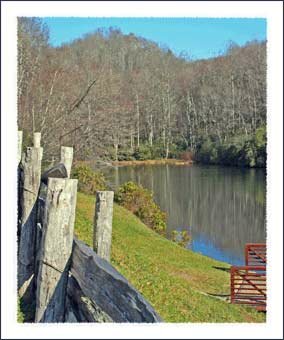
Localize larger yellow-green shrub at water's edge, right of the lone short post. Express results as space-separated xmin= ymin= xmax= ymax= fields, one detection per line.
xmin=115 ymin=182 xmax=166 ymax=235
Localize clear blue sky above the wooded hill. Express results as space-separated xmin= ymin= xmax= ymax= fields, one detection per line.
xmin=43 ymin=17 xmax=266 ymax=59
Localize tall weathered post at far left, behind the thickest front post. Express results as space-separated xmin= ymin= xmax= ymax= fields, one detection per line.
xmin=18 ymin=135 xmax=42 ymax=299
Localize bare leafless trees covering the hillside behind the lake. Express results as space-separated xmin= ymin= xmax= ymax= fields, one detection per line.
xmin=18 ymin=18 xmax=266 ymax=166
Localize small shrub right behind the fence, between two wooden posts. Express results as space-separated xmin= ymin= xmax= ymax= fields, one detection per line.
xmin=72 ymin=163 xmax=106 ymax=194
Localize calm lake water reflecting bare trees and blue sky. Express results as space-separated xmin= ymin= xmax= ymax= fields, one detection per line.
xmin=106 ymin=165 xmax=266 ymax=264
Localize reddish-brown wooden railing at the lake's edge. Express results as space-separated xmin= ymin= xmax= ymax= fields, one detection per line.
xmin=231 ymin=243 xmax=266 ymax=311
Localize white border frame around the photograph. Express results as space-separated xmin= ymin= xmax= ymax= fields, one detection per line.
xmin=1 ymin=1 xmax=283 ymax=339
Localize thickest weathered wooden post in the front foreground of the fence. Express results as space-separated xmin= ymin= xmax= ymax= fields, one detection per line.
xmin=35 ymin=178 xmax=78 ymax=322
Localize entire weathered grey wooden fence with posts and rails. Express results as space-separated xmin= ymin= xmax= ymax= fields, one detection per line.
xmin=17 ymin=132 xmax=161 ymax=322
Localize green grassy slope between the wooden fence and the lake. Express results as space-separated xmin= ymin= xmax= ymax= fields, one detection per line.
xmin=75 ymin=193 xmax=265 ymax=322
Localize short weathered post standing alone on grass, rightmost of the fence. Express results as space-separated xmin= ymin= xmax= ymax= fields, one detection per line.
xmin=93 ymin=191 xmax=114 ymax=261
